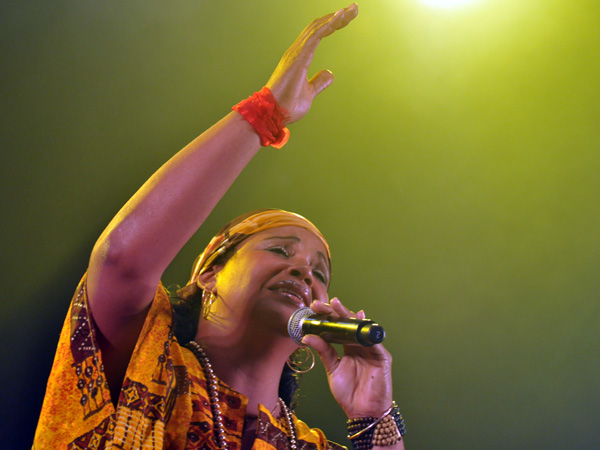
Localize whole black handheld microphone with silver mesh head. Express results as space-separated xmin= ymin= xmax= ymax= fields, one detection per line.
xmin=288 ymin=307 xmax=385 ymax=347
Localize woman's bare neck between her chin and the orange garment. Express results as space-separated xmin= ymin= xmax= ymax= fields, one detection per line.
xmin=195 ymin=320 xmax=295 ymax=415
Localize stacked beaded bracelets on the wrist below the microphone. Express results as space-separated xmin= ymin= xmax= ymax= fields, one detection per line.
xmin=347 ymin=402 xmax=406 ymax=450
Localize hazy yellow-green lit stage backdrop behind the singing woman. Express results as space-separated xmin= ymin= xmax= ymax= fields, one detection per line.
xmin=0 ymin=0 xmax=600 ymax=450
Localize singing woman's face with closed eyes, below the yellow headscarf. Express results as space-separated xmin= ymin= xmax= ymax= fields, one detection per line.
xmin=200 ymin=226 xmax=330 ymax=336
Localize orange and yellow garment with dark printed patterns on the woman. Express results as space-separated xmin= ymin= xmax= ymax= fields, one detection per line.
xmin=33 ymin=277 xmax=343 ymax=450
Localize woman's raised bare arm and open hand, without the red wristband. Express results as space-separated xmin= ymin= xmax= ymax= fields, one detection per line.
xmin=87 ymin=5 xmax=358 ymax=390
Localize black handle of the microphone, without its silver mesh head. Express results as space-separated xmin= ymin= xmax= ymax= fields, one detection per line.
xmin=301 ymin=314 xmax=385 ymax=347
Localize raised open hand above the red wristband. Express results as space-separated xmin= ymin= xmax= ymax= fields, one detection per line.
xmin=267 ymin=3 xmax=358 ymax=123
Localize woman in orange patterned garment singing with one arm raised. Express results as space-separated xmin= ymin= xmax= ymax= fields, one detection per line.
xmin=34 ymin=5 xmax=404 ymax=450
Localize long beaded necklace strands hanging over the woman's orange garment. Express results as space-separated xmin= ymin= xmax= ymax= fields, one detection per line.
xmin=186 ymin=341 xmax=298 ymax=450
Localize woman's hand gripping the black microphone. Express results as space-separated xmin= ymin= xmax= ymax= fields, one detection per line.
xmin=302 ymin=298 xmax=392 ymax=418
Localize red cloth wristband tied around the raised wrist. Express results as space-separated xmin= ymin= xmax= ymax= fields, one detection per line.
xmin=231 ymin=86 xmax=290 ymax=148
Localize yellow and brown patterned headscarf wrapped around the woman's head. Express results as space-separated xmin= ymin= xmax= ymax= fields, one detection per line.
xmin=188 ymin=209 xmax=331 ymax=284
